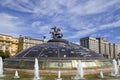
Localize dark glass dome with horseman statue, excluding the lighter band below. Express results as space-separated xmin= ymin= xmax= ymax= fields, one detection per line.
xmin=14 ymin=27 xmax=102 ymax=59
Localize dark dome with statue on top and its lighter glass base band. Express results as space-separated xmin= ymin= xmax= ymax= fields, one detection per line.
xmin=4 ymin=27 xmax=106 ymax=69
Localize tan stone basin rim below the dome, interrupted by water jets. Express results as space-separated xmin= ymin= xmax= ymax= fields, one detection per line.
xmin=4 ymin=67 xmax=112 ymax=75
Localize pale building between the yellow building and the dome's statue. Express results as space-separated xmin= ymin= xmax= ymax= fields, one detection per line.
xmin=18 ymin=36 xmax=46 ymax=52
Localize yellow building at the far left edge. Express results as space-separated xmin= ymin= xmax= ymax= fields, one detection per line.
xmin=0 ymin=34 xmax=18 ymax=56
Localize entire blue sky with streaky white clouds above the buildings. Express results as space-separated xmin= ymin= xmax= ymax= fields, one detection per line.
xmin=0 ymin=0 xmax=120 ymax=44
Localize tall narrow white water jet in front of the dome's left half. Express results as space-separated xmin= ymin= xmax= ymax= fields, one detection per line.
xmin=33 ymin=58 xmax=41 ymax=80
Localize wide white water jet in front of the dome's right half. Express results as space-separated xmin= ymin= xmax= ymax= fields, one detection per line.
xmin=73 ymin=60 xmax=85 ymax=80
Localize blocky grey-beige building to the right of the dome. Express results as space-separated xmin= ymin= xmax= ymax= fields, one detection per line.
xmin=80 ymin=37 xmax=118 ymax=58
